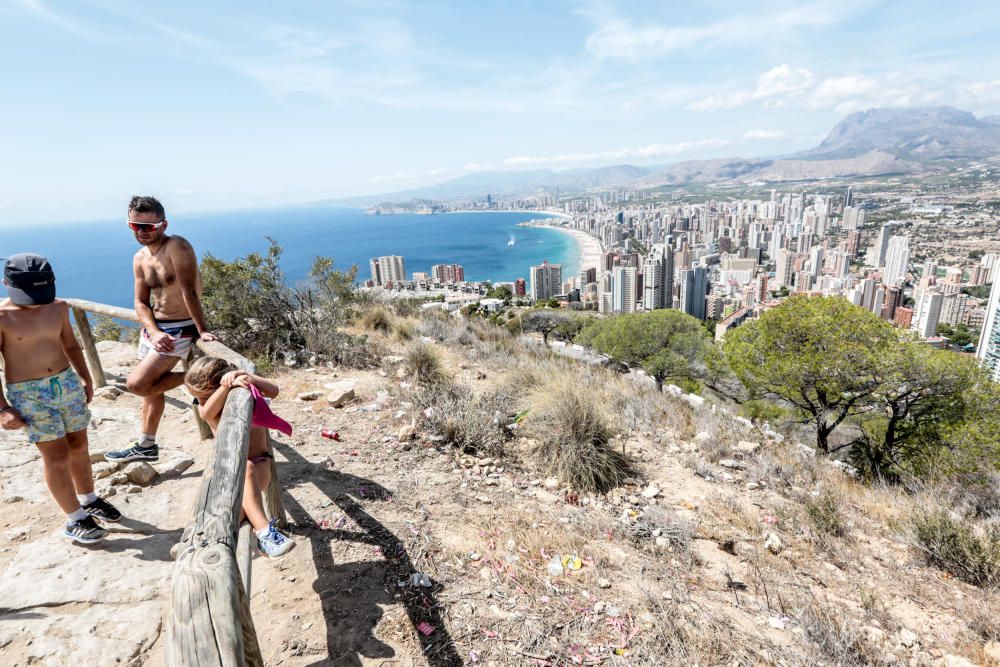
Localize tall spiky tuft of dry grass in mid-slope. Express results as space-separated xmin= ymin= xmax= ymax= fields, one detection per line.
xmin=527 ymin=372 xmax=632 ymax=493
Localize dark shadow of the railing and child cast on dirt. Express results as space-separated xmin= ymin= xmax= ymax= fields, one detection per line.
xmin=272 ymin=440 xmax=463 ymax=667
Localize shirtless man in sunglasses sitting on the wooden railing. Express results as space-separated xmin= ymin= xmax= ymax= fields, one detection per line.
xmin=104 ymin=197 xmax=217 ymax=462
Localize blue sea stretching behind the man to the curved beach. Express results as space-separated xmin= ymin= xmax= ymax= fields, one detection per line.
xmin=0 ymin=207 xmax=579 ymax=307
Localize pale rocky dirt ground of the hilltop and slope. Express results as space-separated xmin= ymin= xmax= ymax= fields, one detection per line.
xmin=0 ymin=336 xmax=1000 ymax=667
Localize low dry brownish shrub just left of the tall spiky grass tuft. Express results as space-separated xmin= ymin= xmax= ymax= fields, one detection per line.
xmin=419 ymin=384 xmax=518 ymax=458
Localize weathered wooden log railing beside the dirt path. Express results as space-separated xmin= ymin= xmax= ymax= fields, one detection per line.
xmin=66 ymin=299 xmax=285 ymax=667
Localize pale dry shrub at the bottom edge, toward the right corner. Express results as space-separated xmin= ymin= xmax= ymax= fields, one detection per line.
xmin=799 ymin=599 xmax=889 ymax=667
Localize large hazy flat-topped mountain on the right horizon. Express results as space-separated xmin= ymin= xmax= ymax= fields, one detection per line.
xmin=793 ymin=107 xmax=1000 ymax=161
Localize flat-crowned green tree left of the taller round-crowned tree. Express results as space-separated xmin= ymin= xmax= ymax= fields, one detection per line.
xmin=577 ymin=309 xmax=712 ymax=391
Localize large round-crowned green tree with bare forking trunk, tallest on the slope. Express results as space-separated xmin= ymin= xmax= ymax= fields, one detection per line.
xmin=724 ymin=296 xmax=897 ymax=452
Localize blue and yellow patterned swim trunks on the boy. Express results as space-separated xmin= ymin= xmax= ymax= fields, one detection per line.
xmin=7 ymin=368 xmax=90 ymax=442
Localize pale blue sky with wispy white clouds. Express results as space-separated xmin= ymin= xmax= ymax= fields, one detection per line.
xmin=0 ymin=0 xmax=1000 ymax=225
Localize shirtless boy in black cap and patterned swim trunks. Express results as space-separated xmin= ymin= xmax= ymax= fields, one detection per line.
xmin=0 ymin=253 xmax=121 ymax=544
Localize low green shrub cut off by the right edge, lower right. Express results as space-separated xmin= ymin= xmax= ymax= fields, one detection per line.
xmin=910 ymin=507 xmax=1000 ymax=588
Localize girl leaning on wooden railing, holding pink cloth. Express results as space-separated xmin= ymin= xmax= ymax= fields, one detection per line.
xmin=184 ymin=357 xmax=295 ymax=558
